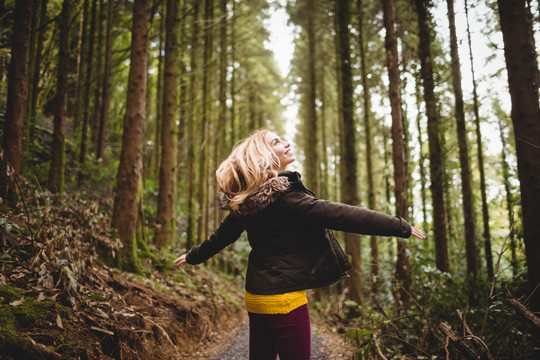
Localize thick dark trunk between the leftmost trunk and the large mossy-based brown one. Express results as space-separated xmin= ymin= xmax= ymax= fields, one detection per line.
xmin=47 ymin=0 xmax=71 ymax=196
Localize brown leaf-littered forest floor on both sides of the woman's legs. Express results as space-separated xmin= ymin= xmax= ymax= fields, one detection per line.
xmin=0 ymin=198 xmax=354 ymax=360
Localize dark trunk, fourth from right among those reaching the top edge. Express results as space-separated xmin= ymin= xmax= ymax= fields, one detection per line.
xmin=415 ymin=0 xmax=450 ymax=272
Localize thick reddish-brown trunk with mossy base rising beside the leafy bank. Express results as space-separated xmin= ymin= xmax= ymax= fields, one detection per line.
xmin=112 ymin=0 xmax=150 ymax=273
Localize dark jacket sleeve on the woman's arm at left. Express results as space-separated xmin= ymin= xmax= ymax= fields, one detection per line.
xmin=186 ymin=213 xmax=244 ymax=265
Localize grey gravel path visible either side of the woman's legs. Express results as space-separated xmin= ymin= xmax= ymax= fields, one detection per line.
xmin=202 ymin=325 xmax=354 ymax=360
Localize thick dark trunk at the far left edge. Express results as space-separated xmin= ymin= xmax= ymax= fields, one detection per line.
xmin=0 ymin=0 xmax=33 ymax=199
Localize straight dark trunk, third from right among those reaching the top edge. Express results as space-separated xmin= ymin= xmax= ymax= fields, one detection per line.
xmin=446 ymin=0 xmax=478 ymax=281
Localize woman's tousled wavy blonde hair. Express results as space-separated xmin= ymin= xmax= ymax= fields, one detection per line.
xmin=216 ymin=130 xmax=280 ymax=211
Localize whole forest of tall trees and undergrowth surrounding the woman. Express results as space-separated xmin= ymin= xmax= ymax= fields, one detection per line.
xmin=0 ymin=0 xmax=540 ymax=359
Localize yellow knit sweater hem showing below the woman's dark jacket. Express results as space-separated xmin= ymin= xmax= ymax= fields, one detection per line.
xmin=245 ymin=290 xmax=308 ymax=314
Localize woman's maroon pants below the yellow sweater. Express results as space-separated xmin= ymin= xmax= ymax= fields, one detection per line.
xmin=248 ymin=305 xmax=311 ymax=360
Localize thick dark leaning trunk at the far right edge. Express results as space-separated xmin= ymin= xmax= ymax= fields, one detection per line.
xmin=497 ymin=0 xmax=540 ymax=311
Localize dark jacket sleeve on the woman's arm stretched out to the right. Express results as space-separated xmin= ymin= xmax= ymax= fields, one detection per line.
xmin=282 ymin=191 xmax=411 ymax=238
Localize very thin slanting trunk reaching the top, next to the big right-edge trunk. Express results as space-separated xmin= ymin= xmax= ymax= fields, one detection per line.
xmin=465 ymin=0 xmax=493 ymax=279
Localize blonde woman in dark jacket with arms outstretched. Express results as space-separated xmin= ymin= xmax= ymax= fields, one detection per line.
xmin=174 ymin=130 xmax=424 ymax=360
